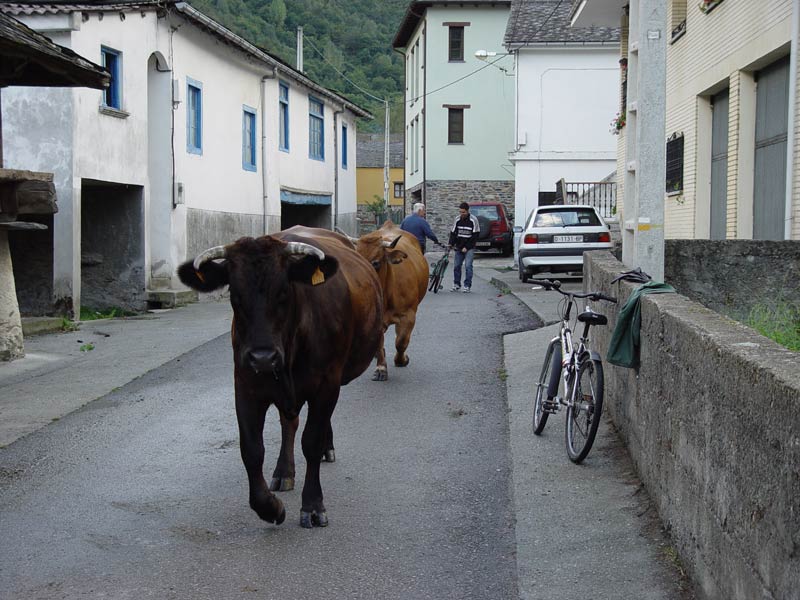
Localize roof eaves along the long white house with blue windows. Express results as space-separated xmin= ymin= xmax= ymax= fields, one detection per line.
xmin=0 ymin=0 xmax=373 ymax=119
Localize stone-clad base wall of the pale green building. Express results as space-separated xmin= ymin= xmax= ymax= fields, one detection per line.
xmin=425 ymin=180 xmax=514 ymax=241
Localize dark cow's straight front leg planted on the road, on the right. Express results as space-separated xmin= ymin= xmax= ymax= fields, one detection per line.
xmin=300 ymin=388 xmax=339 ymax=528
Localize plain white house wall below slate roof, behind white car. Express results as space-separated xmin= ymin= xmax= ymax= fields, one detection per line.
xmin=511 ymin=45 xmax=619 ymax=225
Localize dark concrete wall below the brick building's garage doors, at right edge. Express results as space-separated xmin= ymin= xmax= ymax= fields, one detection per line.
xmin=664 ymin=240 xmax=800 ymax=319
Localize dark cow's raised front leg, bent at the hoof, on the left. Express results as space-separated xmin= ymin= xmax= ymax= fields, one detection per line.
xmin=236 ymin=377 xmax=286 ymax=525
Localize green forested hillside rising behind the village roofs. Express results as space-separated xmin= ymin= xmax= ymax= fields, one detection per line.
xmin=190 ymin=0 xmax=408 ymax=131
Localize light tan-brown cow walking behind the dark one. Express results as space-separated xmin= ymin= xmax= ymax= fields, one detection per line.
xmin=351 ymin=221 xmax=429 ymax=381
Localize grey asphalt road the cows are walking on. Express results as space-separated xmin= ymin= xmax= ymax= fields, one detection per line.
xmin=0 ymin=280 xmax=535 ymax=600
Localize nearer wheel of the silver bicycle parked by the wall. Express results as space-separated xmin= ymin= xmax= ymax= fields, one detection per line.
xmin=566 ymin=357 xmax=603 ymax=464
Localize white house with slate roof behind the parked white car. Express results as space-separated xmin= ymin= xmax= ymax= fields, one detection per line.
xmin=505 ymin=0 xmax=620 ymax=225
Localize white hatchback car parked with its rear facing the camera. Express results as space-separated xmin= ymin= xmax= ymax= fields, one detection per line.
xmin=518 ymin=204 xmax=612 ymax=282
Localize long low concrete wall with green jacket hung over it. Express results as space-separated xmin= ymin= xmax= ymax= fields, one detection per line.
xmin=584 ymin=252 xmax=800 ymax=600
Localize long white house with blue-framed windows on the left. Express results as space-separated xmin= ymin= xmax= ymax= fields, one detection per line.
xmin=0 ymin=0 xmax=370 ymax=314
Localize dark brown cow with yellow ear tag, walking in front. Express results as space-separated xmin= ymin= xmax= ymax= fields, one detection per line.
xmin=178 ymin=226 xmax=383 ymax=527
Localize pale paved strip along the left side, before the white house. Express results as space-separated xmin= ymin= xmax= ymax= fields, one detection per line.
xmin=0 ymin=301 xmax=232 ymax=448
